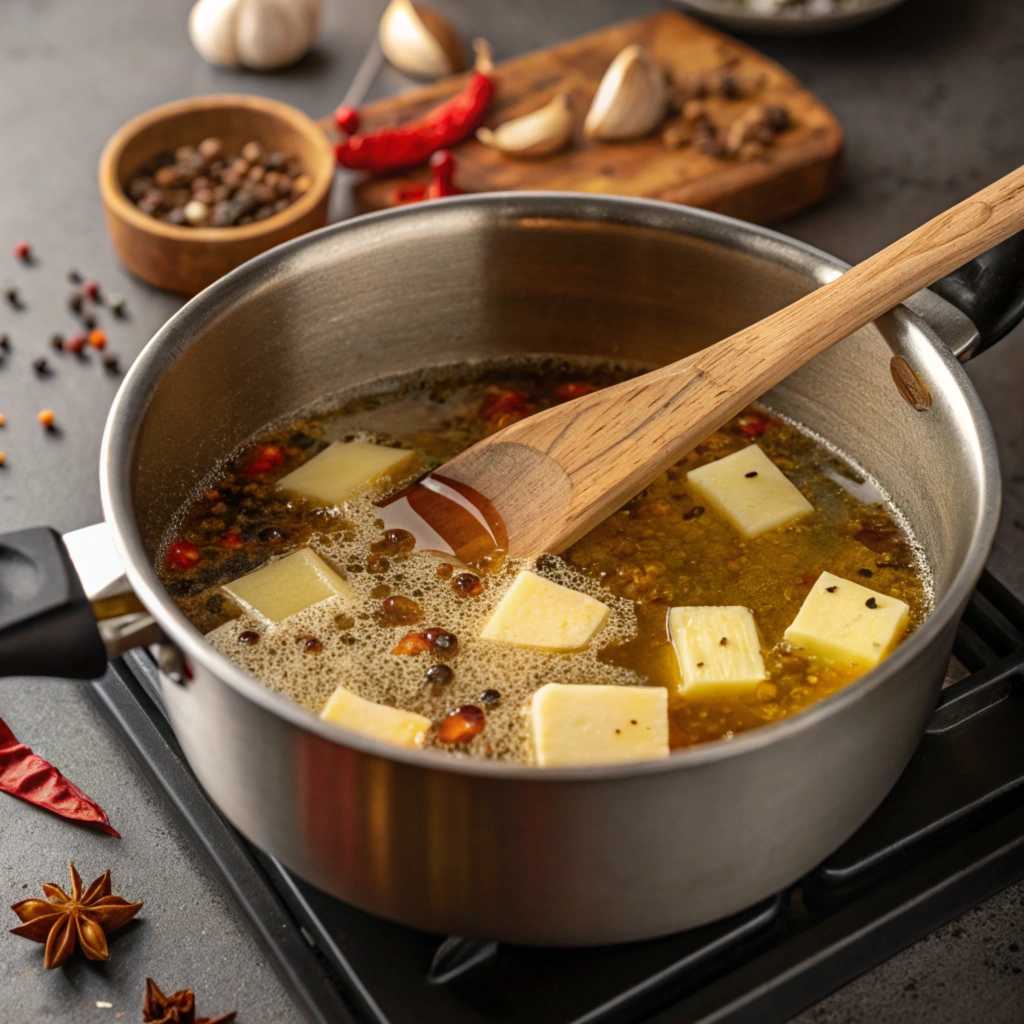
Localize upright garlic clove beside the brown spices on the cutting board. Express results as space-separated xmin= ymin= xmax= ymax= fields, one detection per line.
xmin=583 ymin=43 xmax=669 ymax=141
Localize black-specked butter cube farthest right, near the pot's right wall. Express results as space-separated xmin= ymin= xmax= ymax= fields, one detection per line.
xmin=785 ymin=572 xmax=910 ymax=671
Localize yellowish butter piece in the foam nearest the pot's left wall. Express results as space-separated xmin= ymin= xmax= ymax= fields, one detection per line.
xmin=224 ymin=548 xmax=355 ymax=623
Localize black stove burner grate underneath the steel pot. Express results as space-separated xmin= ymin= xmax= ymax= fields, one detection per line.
xmin=88 ymin=573 xmax=1024 ymax=1024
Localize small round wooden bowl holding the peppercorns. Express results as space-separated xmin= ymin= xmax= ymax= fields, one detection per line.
xmin=99 ymin=95 xmax=335 ymax=295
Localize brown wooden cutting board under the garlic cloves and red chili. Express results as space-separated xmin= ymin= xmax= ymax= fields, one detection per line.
xmin=339 ymin=12 xmax=843 ymax=223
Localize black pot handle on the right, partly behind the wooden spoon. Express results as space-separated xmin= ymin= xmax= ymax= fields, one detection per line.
xmin=932 ymin=231 xmax=1024 ymax=355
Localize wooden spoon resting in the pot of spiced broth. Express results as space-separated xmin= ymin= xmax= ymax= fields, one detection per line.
xmin=385 ymin=168 xmax=1024 ymax=557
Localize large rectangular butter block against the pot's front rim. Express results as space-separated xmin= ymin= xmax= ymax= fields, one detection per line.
xmin=529 ymin=683 xmax=669 ymax=767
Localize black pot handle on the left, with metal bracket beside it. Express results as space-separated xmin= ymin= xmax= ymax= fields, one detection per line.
xmin=0 ymin=526 xmax=106 ymax=679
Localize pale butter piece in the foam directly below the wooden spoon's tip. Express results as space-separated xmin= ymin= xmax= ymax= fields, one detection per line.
xmin=480 ymin=569 xmax=608 ymax=650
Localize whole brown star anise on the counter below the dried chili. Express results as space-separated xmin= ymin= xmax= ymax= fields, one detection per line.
xmin=11 ymin=863 xmax=142 ymax=971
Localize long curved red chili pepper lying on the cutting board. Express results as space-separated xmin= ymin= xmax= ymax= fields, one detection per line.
xmin=334 ymin=39 xmax=495 ymax=174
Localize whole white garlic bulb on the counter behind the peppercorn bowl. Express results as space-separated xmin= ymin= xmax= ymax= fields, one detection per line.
xmin=188 ymin=0 xmax=319 ymax=71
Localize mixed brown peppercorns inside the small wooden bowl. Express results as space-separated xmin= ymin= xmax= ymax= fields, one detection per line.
xmin=125 ymin=137 xmax=312 ymax=228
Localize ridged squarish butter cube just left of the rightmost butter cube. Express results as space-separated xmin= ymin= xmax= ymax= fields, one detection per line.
xmin=669 ymin=606 xmax=768 ymax=697
